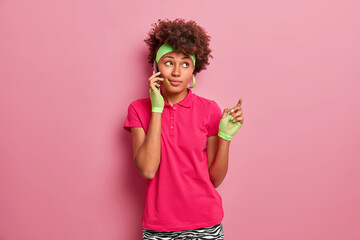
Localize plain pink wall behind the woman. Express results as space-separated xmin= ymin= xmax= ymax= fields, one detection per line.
xmin=0 ymin=0 xmax=360 ymax=240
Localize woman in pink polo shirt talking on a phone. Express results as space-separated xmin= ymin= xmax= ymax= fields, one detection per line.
xmin=124 ymin=19 xmax=244 ymax=239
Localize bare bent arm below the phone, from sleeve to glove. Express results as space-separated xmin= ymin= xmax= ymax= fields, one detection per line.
xmin=131 ymin=112 xmax=161 ymax=179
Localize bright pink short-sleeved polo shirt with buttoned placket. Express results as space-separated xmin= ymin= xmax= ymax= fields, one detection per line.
xmin=124 ymin=89 xmax=224 ymax=231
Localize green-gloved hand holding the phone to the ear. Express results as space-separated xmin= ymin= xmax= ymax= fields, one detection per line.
xmin=149 ymin=71 xmax=165 ymax=113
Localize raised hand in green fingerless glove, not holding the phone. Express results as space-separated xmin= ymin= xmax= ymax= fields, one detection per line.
xmin=218 ymin=98 xmax=244 ymax=141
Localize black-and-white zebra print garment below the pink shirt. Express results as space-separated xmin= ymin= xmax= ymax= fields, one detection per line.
xmin=143 ymin=222 xmax=224 ymax=240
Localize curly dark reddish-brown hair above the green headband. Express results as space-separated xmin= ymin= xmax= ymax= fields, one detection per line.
xmin=144 ymin=18 xmax=213 ymax=75
